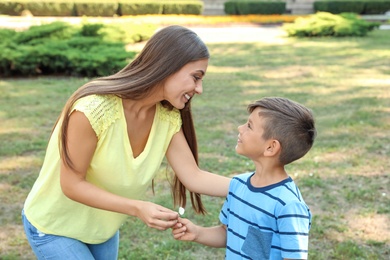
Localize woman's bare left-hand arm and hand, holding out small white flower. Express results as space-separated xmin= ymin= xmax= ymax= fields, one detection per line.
xmin=60 ymin=111 xmax=178 ymax=230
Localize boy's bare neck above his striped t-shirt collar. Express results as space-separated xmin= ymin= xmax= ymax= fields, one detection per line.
xmin=250 ymin=165 xmax=288 ymax=188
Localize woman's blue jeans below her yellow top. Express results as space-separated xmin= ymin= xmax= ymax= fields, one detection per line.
xmin=22 ymin=212 xmax=119 ymax=260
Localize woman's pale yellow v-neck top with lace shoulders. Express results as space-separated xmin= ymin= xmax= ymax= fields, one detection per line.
xmin=24 ymin=95 xmax=181 ymax=244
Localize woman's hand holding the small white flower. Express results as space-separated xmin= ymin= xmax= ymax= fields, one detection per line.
xmin=135 ymin=201 xmax=179 ymax=230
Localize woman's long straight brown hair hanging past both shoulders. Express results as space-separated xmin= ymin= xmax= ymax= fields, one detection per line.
xmin=56 ymin=25 xmax=209 ymax=214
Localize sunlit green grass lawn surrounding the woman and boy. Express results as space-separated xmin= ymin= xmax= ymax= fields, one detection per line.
xmin=0 ymin=23 xmax=390 ymax=260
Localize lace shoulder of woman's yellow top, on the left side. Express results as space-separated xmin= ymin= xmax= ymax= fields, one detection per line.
xmin=74 ymin=95 xmax=121 ymax=139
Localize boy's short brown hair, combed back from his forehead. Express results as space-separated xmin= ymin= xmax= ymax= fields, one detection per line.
xmin=248 ymin=97 xmax=317 ymax=165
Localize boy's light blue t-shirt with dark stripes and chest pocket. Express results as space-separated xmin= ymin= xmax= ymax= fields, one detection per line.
xmin=219 ymin=173 xmax=311 ymax=260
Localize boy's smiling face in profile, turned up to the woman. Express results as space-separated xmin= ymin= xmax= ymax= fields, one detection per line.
xmin=236 ymin=108 xmax=266 ymax=160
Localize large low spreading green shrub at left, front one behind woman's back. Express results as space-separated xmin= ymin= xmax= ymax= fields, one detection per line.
xmin=0 ymin=37 xmax=135 ymax=77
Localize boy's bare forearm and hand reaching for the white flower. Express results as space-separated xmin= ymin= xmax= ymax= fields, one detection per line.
xmin=172 ymin=218 xmax=226 ymax=247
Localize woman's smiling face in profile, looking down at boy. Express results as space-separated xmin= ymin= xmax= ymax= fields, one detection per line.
xmin=164 ymin=59 xmax=209 ymax=109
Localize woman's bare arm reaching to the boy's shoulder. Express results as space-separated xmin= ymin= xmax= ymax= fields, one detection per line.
xmin=166 ymin=130 xmax=230 ymax=197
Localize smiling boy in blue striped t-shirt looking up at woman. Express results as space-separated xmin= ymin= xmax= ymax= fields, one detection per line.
xmin=172 ymin=98 xmax=316 ymax=260
